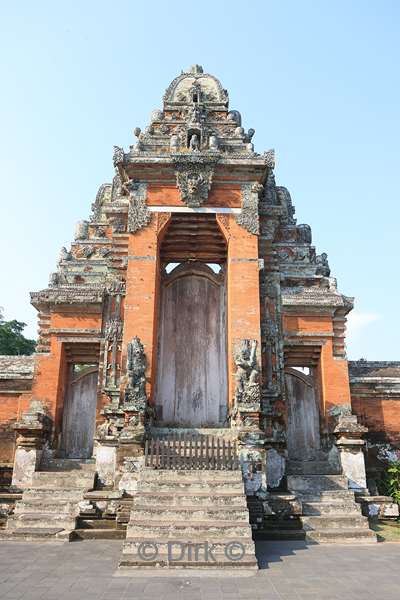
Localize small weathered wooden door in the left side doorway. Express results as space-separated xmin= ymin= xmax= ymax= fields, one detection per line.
xmin=61 ymin=365 xmax=98 ymax=458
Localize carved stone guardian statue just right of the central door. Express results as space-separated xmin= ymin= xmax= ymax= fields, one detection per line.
xmin=235 ymin=339 xmax=260 ymax=405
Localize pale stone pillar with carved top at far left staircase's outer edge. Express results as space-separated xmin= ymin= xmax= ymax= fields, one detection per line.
xmin=11 ymin=399 xmax=51 ymax=489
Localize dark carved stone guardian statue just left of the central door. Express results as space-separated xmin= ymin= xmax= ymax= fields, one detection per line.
xmin=125 ymin=336 xmax=147 ymax=411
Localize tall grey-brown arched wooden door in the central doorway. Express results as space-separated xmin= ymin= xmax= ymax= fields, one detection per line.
xmin=156 ymin=263 xmax=227 ymax=427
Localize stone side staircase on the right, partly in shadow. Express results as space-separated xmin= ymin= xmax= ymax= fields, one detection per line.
xmin=287 ymin=474 xmax=377 ymax=544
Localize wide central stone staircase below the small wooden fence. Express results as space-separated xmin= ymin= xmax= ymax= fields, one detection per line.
xmin=119 ymin=468 xmax=257 ymax=574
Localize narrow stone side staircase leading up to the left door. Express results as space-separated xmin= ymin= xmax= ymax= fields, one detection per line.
xmin=0 ymin=459 xmax=95 ymax=541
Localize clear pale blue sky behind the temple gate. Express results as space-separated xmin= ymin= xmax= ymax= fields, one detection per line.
xmin=0 ymin=0 xmax=400 ymax=360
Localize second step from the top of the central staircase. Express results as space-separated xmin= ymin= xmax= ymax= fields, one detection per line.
xmin=139 ymin=478 xmax=243 ymax=495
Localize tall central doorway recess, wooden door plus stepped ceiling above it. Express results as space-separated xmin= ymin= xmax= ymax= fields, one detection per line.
xmin=155 ymin=214 xmax=228 ymax=428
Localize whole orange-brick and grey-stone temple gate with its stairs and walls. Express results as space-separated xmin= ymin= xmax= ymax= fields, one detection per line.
xmin=0 ymin=65 xmax=400 ymax=570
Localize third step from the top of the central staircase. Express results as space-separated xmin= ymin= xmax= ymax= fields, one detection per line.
xmin=135 ymin=489 xmax=246 ymax=508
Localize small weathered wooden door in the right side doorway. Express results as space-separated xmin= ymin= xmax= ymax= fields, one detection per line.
xmin=285 ymin=369 xmax=320 ymax=460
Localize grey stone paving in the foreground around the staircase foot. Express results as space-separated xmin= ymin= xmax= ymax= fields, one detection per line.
xmin=0 ymin=541 xmax=400 ymax=600
